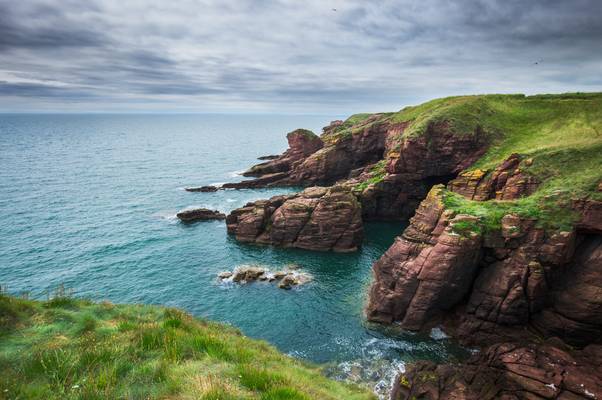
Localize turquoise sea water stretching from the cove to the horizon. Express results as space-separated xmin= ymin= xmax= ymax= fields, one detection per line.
xmin=0 ymin=115 xmax=461 ymax=396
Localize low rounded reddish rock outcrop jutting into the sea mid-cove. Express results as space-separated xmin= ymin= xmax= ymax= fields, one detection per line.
xmin=226 ymin=186 xmax=363 ymax=252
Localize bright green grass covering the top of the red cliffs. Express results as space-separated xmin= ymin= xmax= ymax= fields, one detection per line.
xmin=336 ymin=93 xmax=602 ymax=230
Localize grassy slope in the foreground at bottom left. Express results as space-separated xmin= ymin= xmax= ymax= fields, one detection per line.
xmin=0 ymin=294 xmax=374 ymax=400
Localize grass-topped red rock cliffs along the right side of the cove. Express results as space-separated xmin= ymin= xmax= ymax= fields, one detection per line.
xmin=224 ymin=93 xmax=602 ymax=399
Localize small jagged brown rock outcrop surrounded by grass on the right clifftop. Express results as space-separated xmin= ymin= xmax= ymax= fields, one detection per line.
xmin=449 ymin=154 xmax=539 ymax=201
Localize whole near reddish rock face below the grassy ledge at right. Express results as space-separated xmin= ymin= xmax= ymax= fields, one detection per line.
xmin=367 ymin=180 xmax=602 ymax=346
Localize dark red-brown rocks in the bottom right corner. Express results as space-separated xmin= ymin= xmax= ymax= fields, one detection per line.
xmin=391 ymin=342 xmax=602 ymax=400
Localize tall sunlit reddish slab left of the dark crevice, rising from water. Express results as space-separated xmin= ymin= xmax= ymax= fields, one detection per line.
xmin=367 ymin=186 xmax=481 ymax=330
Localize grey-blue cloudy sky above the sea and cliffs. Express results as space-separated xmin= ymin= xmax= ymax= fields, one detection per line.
xmin=0 ymin=0 xmax=602 ymax=114
